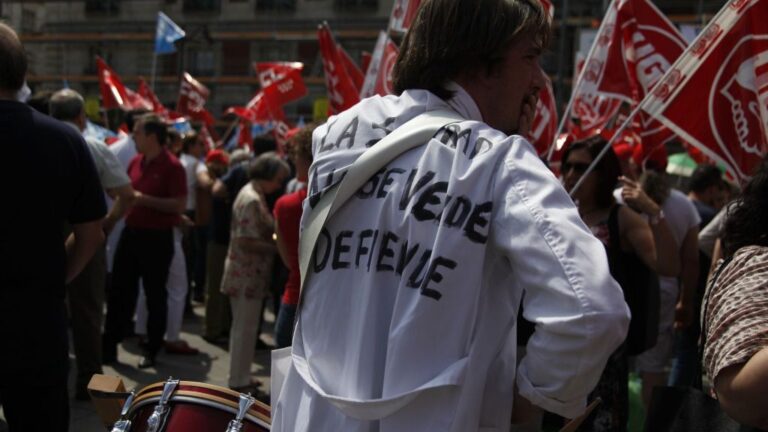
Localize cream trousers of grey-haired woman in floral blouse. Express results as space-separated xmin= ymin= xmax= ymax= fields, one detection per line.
xmin=229 ymin=289 xmax=264 ymax=387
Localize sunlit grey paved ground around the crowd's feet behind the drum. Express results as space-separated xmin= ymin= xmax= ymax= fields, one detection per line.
xmin=0 ymin=306 xmax=274 ymax=432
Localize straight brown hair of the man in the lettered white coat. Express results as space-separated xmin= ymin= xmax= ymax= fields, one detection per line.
xmin=392 ymin=0 xmax=551 ymax=100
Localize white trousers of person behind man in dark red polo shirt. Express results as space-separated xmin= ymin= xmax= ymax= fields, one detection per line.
xmin=134 ymin=228 xmax=189 ymax=342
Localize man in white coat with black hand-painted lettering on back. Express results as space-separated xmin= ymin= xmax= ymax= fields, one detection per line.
xmin=272 ymin=0 xmax=629 ymax=432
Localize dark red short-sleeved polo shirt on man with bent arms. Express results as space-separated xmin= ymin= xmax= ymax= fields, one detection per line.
xmin=125 ymin=149 xmax=187 ymax=229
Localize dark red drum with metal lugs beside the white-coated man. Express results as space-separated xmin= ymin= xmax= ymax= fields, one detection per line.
xmin=112 ymin=379 xmax=270 ymax=432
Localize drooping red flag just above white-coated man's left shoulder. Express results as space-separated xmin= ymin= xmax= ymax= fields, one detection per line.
xmin=317 ymin=23 xmax=360 ymax=114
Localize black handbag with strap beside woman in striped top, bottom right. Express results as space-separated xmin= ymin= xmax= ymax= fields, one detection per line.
xmin=645 ymin=261 xmax=758 ymax=432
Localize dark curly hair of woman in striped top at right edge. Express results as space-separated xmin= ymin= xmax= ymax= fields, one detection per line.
xmin=723 ymin=156 xmax=768 ymax=258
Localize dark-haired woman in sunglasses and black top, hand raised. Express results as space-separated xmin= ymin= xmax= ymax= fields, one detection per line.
xmin=560 ymin=136 xmax=680 ymax=431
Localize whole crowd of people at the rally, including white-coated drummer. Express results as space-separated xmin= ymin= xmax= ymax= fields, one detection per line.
xmin=0 ymin=0 xmax=768 ymax=432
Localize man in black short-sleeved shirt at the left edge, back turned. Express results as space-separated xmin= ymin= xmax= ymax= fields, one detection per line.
xmin=0 ymin=24 xmax=106 ymax=432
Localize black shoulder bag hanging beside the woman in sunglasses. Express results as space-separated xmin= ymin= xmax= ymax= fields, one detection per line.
xmin=608 ymin=205 xmax=660 ymax=356
